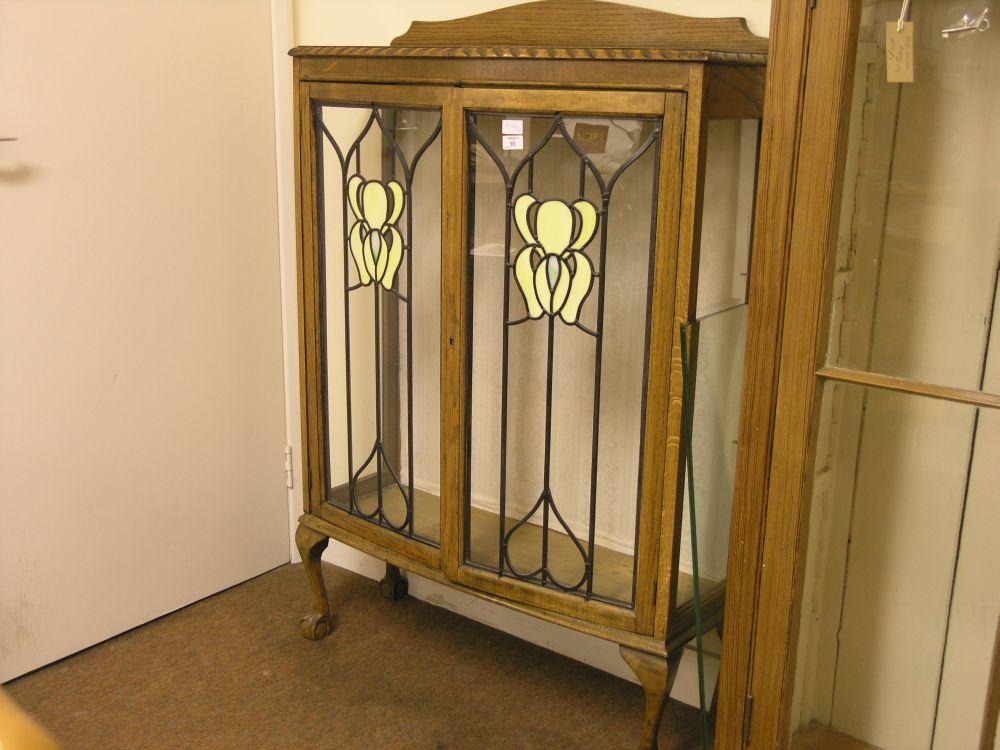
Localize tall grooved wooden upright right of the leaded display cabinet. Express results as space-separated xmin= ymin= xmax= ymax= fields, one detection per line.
xmin=716 ymin=0 xmax=861 ymax=748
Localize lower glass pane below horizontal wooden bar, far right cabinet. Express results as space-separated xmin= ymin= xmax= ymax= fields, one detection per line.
xmin=792 ymin=382 xmax=1000 ymax=748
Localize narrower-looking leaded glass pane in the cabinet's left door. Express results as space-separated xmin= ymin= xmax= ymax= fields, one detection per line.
xmin=315 ymin=104 xmax=441 ymax=544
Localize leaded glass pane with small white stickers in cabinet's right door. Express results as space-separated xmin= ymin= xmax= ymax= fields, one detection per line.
xmin=466 ymin=113 xmax=660 ymax=605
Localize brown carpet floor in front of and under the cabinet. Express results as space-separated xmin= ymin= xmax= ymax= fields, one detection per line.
xmin=6 ymin=565 xmax=698 ymax=750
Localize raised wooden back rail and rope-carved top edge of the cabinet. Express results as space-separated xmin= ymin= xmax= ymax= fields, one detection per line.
xmin=290 ymin=0 xmax=767 ymax=65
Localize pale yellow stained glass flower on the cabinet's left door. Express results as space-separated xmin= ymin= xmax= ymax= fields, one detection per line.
xmin=347 ymin=174 xmax=405 ymax=289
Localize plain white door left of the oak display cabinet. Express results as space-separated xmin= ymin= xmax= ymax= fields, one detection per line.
xmin=0 ymin=0 xmax=289 ymax=681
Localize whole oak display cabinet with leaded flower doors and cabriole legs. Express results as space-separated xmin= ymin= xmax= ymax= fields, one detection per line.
xmin=292 ymin=0 xmax=767 ymax=748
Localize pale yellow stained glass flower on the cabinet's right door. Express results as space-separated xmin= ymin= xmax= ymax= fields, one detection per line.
xmin=514 ymin=193 xmax=597 ymax=325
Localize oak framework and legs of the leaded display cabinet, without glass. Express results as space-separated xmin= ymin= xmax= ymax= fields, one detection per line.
xmin=292 ymin=0 xmax=774 ymax=747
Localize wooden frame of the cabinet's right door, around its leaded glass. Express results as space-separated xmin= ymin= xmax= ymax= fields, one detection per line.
xmin=441 ymin=88 xmax=686 ymax=635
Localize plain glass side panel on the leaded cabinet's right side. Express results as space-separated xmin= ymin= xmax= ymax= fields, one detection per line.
xmin=677 ymin=119 xmax=760 ymax=604
